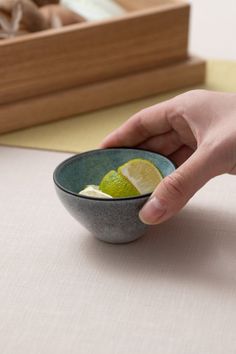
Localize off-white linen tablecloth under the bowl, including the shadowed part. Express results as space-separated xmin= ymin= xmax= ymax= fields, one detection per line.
xmin=0 ymin=147 xmax=236 ymax=354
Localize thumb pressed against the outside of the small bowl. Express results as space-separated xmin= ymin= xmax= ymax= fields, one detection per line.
xmin=139 ymin=148 xmax=217 ymax=224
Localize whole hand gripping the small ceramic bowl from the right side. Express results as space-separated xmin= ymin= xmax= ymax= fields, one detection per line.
xmin=101 ymin=90 xmax=236 ymax=224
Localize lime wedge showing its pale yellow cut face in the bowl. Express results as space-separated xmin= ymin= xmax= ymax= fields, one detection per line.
xmin=118 ymin=158 xmax=163 ymax=194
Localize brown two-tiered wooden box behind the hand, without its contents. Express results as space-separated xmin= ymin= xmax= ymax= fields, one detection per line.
xmin=0 ymin=0 xmax=204 ymax=133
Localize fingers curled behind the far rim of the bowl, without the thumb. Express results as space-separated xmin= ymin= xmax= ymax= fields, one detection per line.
xmin=101 ymin=99 xmax=175 ymax=148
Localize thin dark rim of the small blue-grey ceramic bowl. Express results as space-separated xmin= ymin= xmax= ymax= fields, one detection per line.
xmin=53 ymin=147 xmax=176 ymax=203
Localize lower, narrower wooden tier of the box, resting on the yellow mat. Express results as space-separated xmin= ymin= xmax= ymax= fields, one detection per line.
xmin=0 ymin=58 xmax=205 ymax=133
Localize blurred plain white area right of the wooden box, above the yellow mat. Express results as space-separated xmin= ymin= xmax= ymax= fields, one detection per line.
xmin=189 ymin=0 xmax=236 ymax=60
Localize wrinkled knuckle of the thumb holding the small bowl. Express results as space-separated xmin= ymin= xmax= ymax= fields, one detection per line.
xmin=163 ymin=172 xmax=186 ymax=201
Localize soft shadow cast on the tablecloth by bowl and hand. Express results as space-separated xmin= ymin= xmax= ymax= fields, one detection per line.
xmin=79 ymin=206 xmax=236 ymax=289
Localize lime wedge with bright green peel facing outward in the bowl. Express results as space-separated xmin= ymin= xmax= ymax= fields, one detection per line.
xmin=99 ymin=170 xmax=140 ymax=198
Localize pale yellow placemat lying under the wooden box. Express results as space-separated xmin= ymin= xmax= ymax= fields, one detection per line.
xmin=0 ymin=61 xmax=236 ymax=152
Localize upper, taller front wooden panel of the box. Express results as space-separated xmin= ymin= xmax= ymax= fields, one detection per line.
xmin=0 ymin=3 xmax=189 ymax=104
